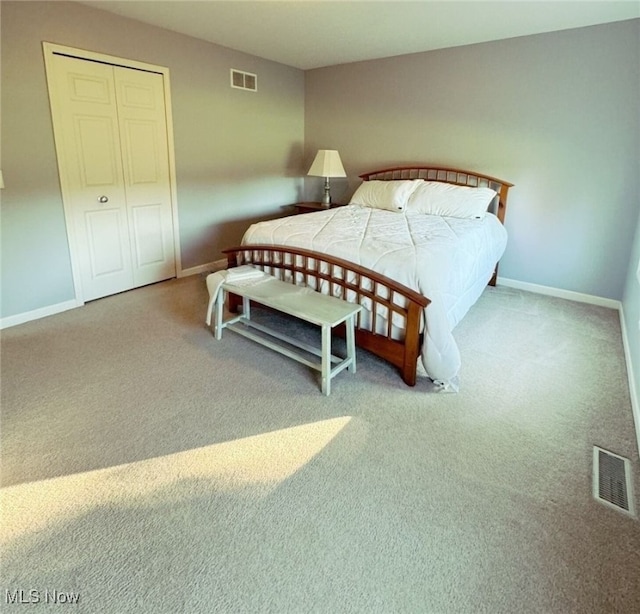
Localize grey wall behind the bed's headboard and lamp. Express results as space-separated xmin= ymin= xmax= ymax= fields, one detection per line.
xmin=305 ymin=19 xmax=640 ymax=300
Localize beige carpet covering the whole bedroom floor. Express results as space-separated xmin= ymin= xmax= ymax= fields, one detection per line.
xmin=0 ymin=276 xmax=640 ymax=614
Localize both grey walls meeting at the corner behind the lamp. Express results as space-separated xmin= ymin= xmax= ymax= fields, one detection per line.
xmin=0 ymin=0 xmax=640 ymax=328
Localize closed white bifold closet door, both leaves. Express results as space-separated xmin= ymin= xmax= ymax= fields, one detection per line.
xmin=52 ymin=54 xmax=176 ymax=301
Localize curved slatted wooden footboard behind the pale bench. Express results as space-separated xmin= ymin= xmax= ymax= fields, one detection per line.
xmin=223 ymin=245 xmax=430 ymax=386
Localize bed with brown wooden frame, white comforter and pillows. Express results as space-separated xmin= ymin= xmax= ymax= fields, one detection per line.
xmin=225 ymin=165 xmax=512 ymax=391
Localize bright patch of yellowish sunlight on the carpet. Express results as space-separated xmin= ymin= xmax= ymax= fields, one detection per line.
xmin=0 ymin=416 xmax=351 ymax=546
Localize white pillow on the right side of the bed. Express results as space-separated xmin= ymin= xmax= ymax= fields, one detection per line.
xmin=406 ymin=181 xmax=496 ymax=219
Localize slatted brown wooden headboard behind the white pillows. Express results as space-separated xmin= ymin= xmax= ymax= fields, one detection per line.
xmin=360 ymin=165 xmax=513 ymax=224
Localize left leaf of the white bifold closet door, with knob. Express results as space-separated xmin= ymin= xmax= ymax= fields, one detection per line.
xmin=53 ymin=55 xmax=134 ymax=301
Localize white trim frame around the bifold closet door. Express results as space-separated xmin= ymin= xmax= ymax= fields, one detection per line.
xmin=42 ymin=41 xmax=182 ymax=306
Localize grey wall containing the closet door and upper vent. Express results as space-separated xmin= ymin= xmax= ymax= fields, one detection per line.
xmin=0 ymin=0 xmax=304 ymax=321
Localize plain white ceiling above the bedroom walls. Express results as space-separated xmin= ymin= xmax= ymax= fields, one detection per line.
xmin=82 ymin=0 xmax=640 ymax=70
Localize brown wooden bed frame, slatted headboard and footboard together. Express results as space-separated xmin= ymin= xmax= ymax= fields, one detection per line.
xmin=223 ymin=165 xmax=513 ymax=386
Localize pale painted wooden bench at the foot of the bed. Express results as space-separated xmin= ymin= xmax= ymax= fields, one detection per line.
xmin=207 ymin=273 xmax=362 ymax=395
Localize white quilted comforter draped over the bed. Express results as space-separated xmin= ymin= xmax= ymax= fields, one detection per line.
xmin=242 ymin=205 xmax=507 ymax=390
